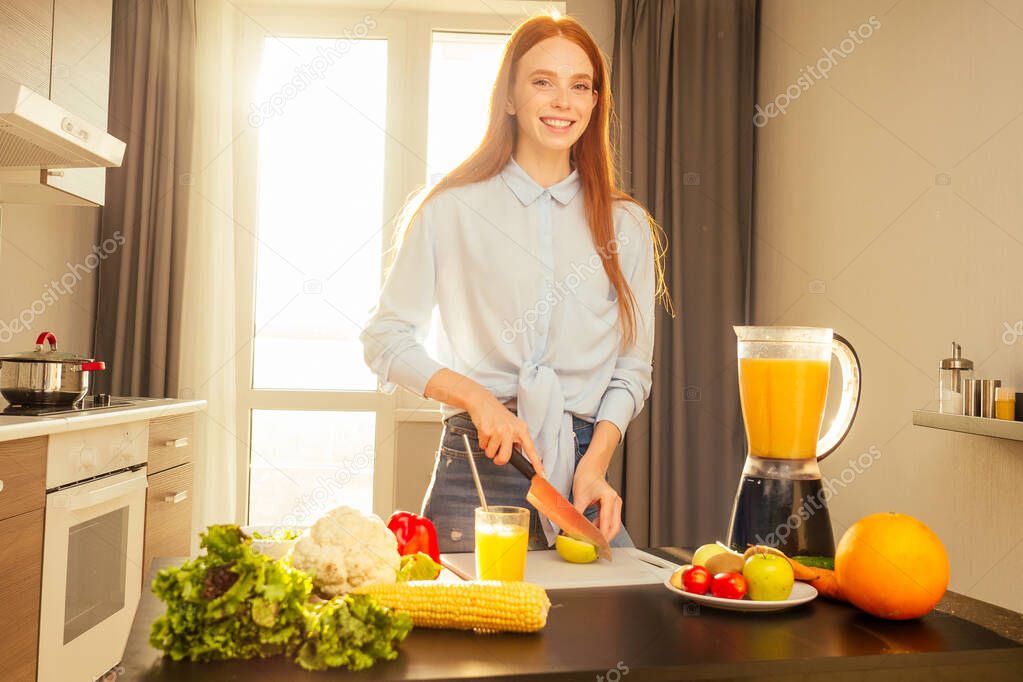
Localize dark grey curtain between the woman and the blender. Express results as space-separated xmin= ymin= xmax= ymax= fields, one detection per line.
xmin=612 ymin=0 xmax=757 ymax=547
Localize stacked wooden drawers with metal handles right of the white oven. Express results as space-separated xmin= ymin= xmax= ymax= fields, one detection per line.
xmin=142 ymin=414 xmax=195 ymax=576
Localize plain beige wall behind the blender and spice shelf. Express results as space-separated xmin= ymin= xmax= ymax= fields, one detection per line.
xmin=754 ymin=0 xmax=1023 ymax=610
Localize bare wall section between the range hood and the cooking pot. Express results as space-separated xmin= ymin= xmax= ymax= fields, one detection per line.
xmin=0 ymin=203 xmax=100 ymax=355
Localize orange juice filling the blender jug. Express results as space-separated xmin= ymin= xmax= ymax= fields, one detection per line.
xmin=739 ymin=357 xmax=831 ymax=459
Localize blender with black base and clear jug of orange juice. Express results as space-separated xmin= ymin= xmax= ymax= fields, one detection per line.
xmin=728 ymin=326 xmax=860 ymax=556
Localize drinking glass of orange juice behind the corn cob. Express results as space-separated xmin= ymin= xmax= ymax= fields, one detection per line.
xmin=476 ymin=506 xmax=529 ymax=581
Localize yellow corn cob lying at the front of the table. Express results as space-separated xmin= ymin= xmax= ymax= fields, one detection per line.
xmin=355 ymin=581 xmax=550 ymax=632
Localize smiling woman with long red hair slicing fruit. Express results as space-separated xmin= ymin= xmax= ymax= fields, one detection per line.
xmin=360 ymin=15 xmax=664 ymax=551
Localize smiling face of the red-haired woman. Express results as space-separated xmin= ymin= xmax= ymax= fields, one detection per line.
xmin=506 ymin=36 xmax=596 ymax=158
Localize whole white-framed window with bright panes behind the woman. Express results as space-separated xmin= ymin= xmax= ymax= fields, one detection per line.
xmin=235 ymin=6 xmax=544 ymax=525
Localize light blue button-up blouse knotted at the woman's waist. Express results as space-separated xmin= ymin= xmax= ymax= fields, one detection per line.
xmin=360 ymin=158 xmax=655 ymax=542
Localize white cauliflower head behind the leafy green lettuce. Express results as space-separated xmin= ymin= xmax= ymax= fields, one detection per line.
xmin=292 ymin=506 xmax=401 ymax=597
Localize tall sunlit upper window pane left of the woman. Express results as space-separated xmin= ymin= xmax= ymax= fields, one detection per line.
xmin=253 ymin=38 xmax=387 ymax=391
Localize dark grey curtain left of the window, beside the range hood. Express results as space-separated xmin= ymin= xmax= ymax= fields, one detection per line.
xmin=94 ymin=0 xmax=195 ymax=397
